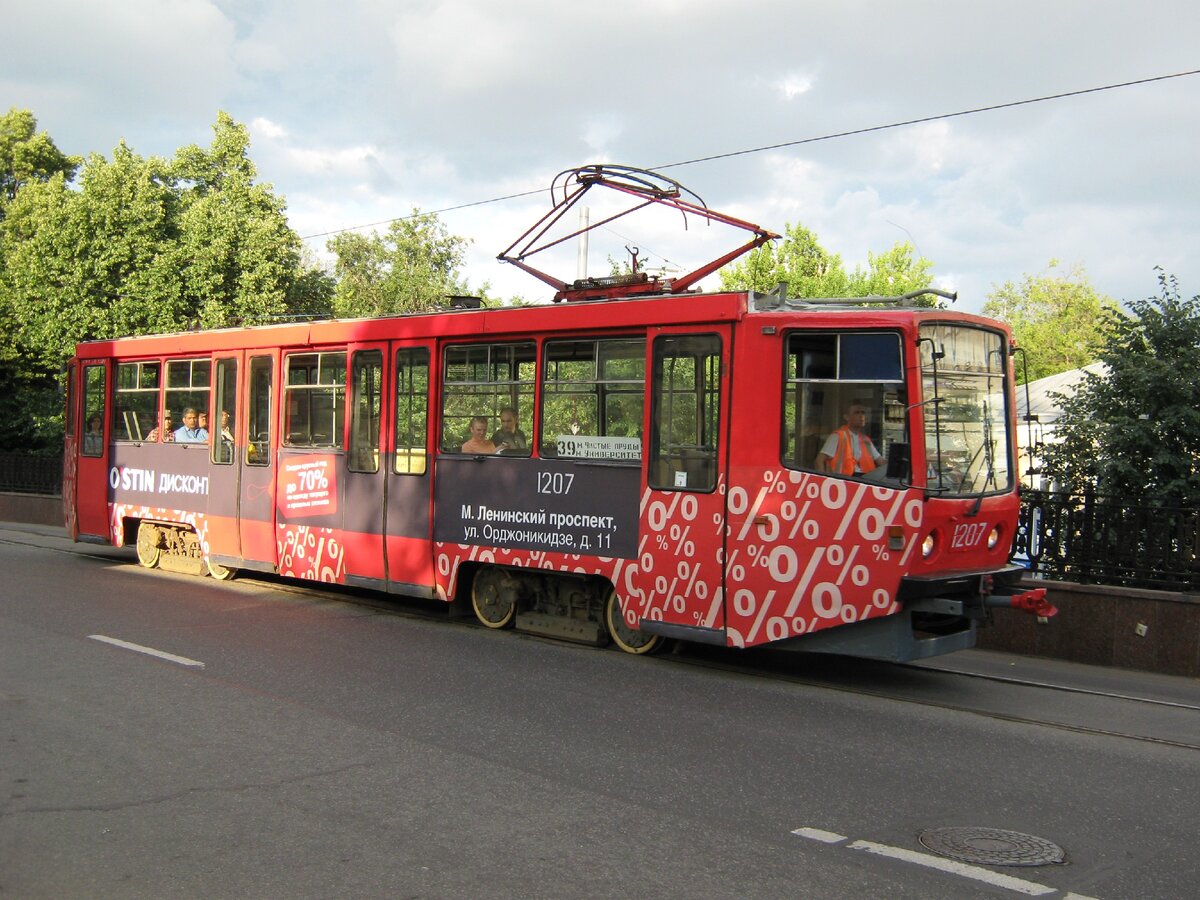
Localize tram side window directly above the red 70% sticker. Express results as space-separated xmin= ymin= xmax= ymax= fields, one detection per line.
xmin=283 ymin=350 xmax=346 ymax=450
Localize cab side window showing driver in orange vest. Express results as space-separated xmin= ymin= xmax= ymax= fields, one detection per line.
xmin=781 ymin=331 xmax=905 ymax=480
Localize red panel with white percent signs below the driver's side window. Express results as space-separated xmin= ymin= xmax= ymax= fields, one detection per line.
xmin=725 ymin=469 xmax=924 ymax=647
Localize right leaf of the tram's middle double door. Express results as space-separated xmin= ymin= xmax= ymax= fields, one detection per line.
xmin=385 ymin=342 xmax=434 ymax=595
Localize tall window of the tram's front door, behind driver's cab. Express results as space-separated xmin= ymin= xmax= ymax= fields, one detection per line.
xmin=649 ymin=335 xmax=721 ymax=491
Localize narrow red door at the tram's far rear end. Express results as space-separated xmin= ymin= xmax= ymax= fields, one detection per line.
xmin=74 ymin=359 xmax=112 ymax=538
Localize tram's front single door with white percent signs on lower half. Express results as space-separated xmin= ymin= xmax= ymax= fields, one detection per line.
xmin=624 ymin=325 xmax=732 ymax=643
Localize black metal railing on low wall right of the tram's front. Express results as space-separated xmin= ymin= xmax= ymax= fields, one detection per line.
xmin=1014 ymin=491 xmax=1200 ymax=592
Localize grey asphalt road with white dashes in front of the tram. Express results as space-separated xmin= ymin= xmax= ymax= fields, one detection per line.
xmin=0 ymin=526 xmax=1200 ymax=899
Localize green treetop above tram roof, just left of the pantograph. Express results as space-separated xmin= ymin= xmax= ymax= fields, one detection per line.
xmin=329 ymin=209 xmax=469 ymax=317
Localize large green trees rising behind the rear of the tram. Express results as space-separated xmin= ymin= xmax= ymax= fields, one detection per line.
xmin=0 ymin=113 xmax=332 ymax=446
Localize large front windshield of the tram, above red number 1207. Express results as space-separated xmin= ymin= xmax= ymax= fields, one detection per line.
xmin=919 ymin=324 xmax=1012 ymax=494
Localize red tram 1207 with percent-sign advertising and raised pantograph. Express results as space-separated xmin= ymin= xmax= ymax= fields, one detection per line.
xmin=64 ymin=166 xmax=1054 ymax=660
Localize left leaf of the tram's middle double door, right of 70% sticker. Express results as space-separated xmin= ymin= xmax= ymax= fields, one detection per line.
xmin=340 ymin=342 xmax=388 ymax=588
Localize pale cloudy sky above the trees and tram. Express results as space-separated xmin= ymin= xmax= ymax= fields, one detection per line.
xmin=0 ymin=0 xmax=1200 ymax=311
